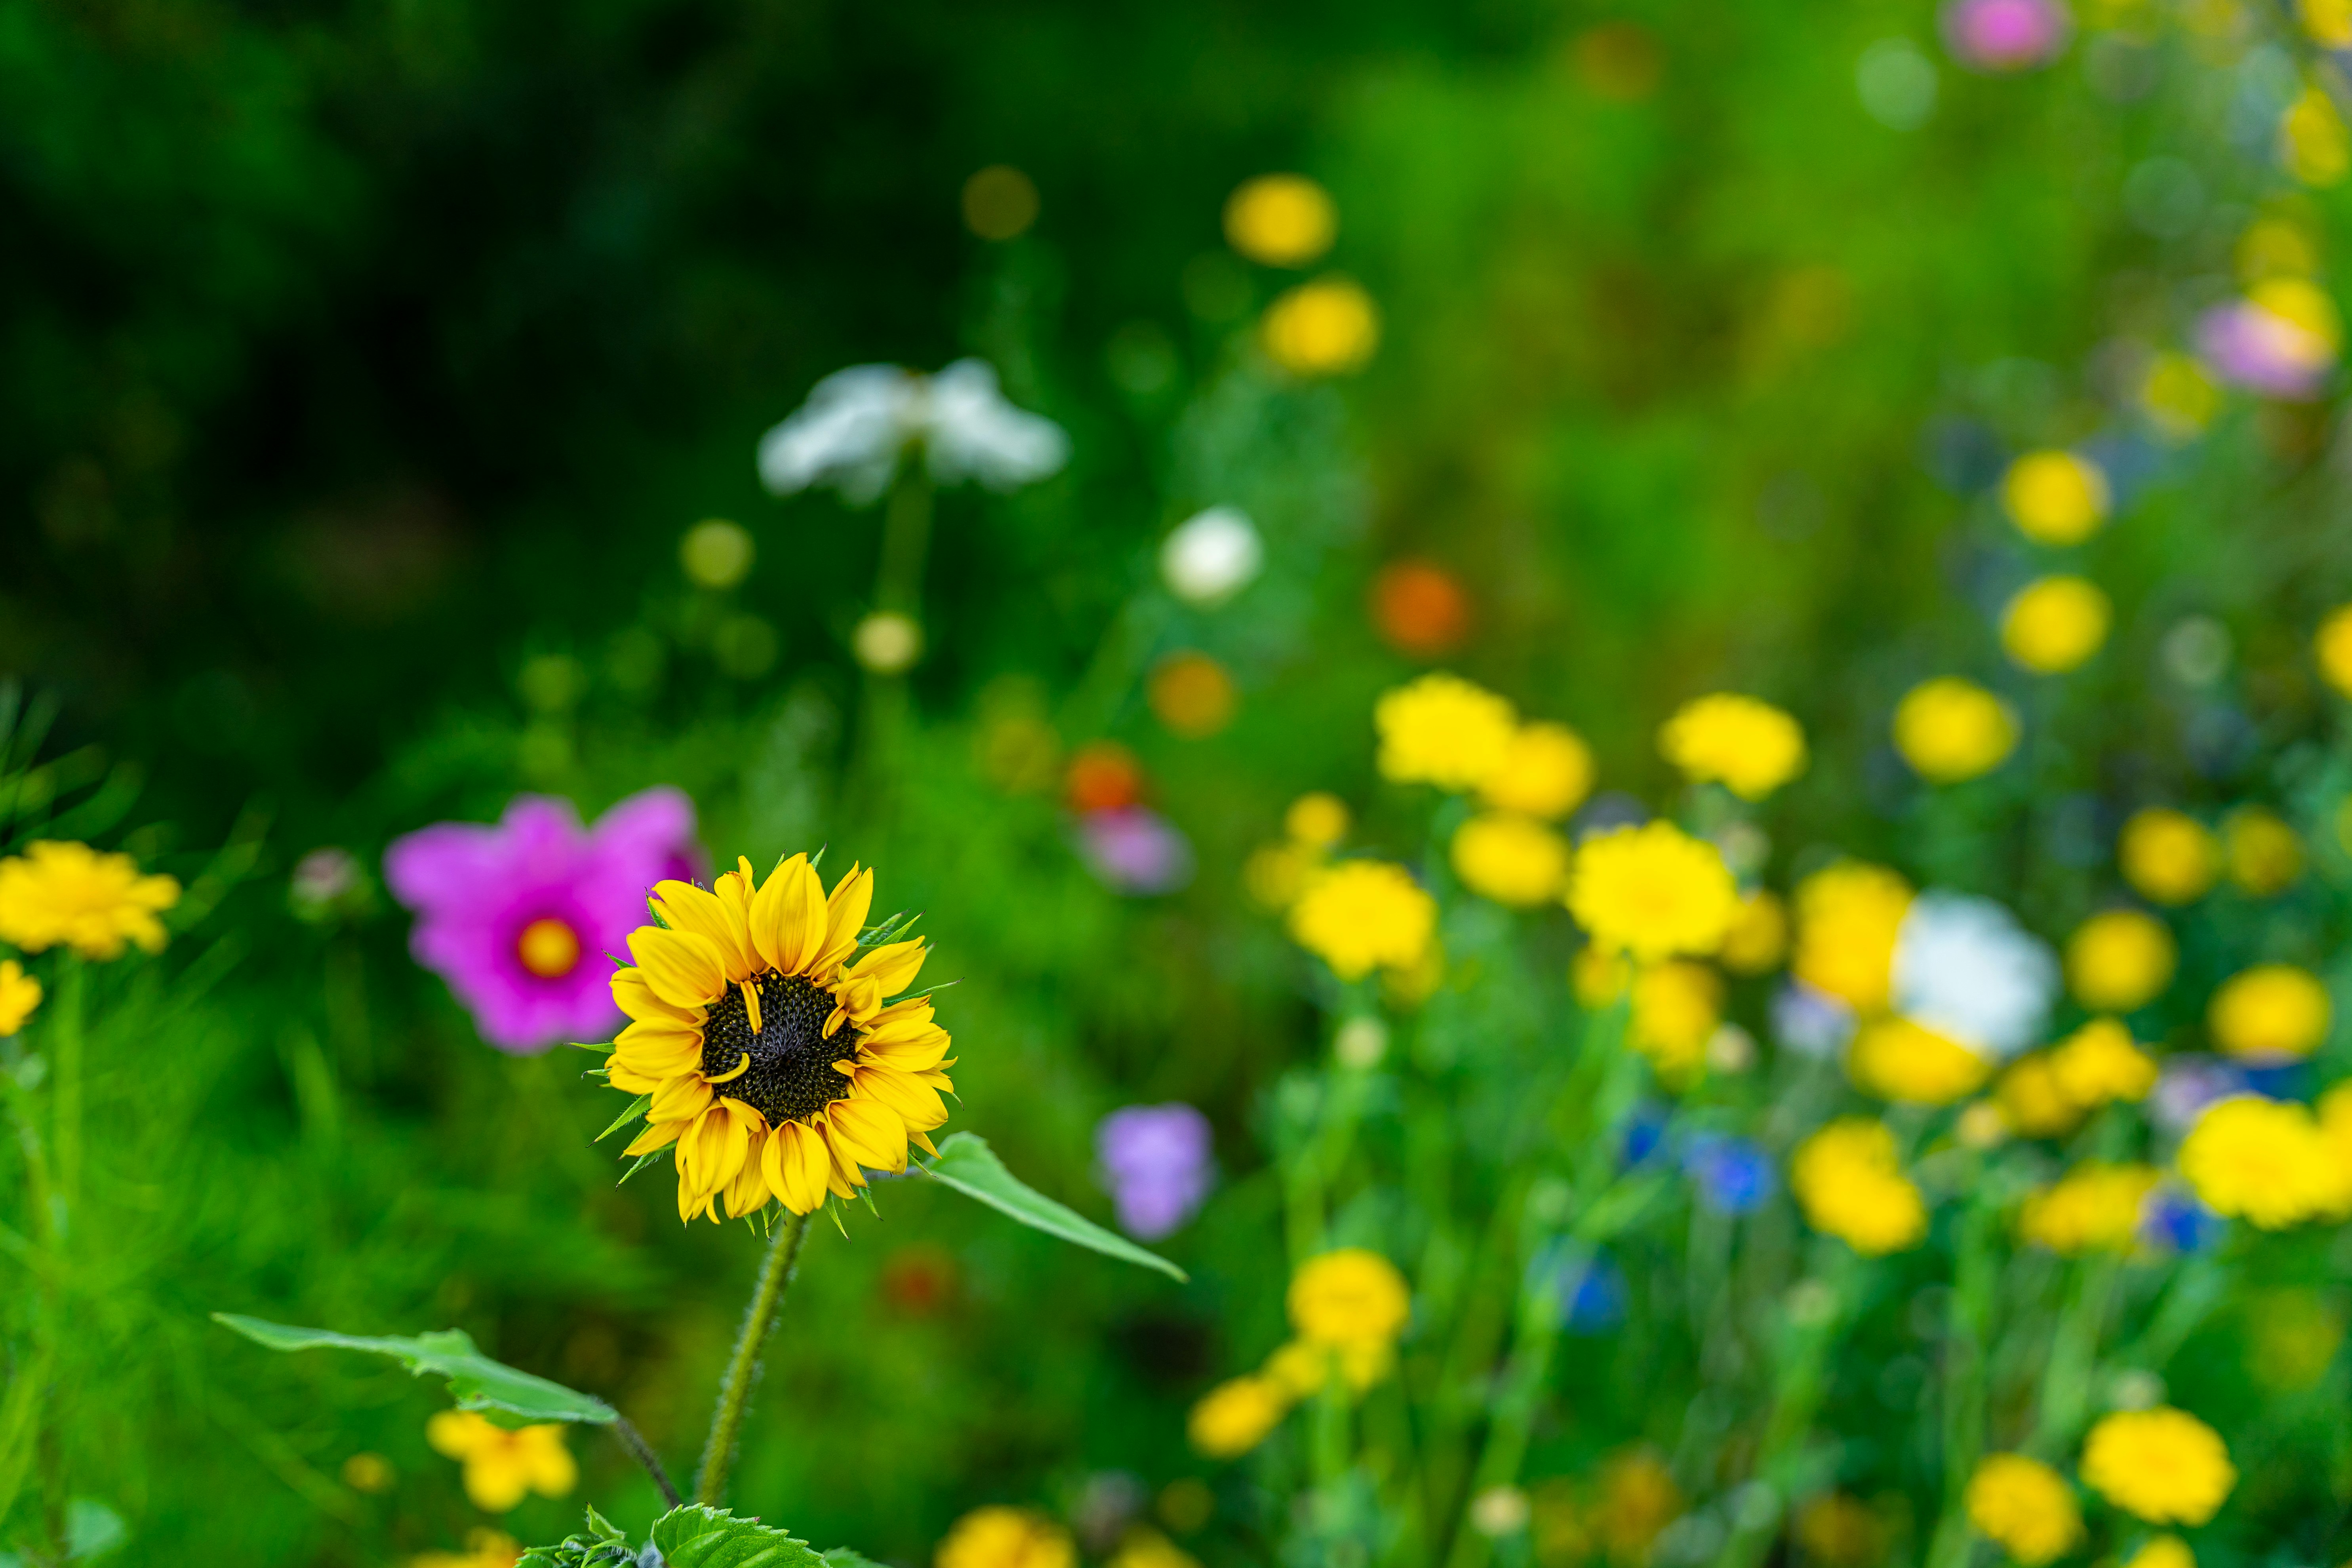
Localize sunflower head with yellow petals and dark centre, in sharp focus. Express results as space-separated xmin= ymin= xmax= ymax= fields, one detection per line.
xmin=609 ymin=856 xmax=955 ymax=1220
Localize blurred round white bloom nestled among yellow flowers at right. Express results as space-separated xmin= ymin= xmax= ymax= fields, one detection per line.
xmin=1893 ymin=891 xmax=2058 ymax=1060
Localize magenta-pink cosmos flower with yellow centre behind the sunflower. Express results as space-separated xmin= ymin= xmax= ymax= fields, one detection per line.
xmin=383 ymin=787 xmax=701 ymax=1053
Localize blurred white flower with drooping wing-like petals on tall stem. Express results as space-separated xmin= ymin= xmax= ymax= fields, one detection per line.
xmin=760 ymin=360 xmax=1070 ymax=505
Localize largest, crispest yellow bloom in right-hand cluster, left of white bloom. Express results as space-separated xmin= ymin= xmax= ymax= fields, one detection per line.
xmin=1569 ymin=823 xmax=1741 ymax=962
